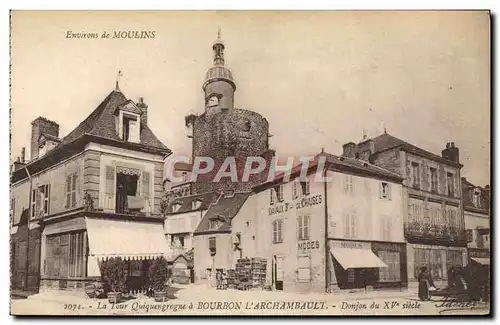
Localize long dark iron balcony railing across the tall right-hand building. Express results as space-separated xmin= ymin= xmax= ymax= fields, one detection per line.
xmin=405 ymin=221 xmax=467 ymax=244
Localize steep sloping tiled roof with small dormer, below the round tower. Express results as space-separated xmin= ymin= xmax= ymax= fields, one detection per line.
xmin=194 ymin=192 xmax=251 ymax=234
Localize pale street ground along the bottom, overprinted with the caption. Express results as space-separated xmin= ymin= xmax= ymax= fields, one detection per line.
xmin=11 ymin=284 xmax=489 ymax=316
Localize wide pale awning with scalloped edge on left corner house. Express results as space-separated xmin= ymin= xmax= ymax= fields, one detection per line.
xmin=85 ymin=217 xmax=169 ymax=260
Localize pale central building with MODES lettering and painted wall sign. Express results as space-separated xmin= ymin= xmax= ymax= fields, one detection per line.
xmin=191 ymin=153 xmax=407 ymax=292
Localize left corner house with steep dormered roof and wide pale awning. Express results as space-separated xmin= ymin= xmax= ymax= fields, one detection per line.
xmin=11 ymin=85 xmax=171 ymax=291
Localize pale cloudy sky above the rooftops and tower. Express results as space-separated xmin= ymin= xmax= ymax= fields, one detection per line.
xmin=11 ymin=11 xmax=490 ymax=186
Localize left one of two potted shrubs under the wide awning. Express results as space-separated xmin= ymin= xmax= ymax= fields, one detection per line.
xmin=101 ymin=257 xmax=127 ymax=303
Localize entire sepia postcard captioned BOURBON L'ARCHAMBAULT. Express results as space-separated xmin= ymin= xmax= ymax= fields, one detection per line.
xmin=10 ymin=10 xmax=491 ymax=316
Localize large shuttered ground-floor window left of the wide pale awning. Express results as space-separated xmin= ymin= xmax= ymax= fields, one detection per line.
xmin=44 ymin=231 xmax=87 ymax=278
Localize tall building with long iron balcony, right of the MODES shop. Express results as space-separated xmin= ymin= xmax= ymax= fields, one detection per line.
xmin=343 ymin=133 xmax=467 ymax=285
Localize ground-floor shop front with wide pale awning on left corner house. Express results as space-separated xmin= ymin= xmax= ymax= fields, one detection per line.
xmin=41 ymin=216 xmax=168 ymax=293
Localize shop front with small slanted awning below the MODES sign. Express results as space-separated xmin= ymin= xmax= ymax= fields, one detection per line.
xmin=328 ymin=240 xmax=407 ymax=291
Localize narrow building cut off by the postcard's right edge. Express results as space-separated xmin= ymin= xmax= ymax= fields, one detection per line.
xmin=462 ymin=177 xmax=491 ymax=265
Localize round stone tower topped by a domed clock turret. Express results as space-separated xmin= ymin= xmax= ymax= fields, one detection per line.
xmin=186 ymin=31 xmax=274 ymax=193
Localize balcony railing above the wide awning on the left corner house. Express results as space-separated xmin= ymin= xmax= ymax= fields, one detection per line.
xmin=83 ymin=191 xmax=154 ymax=216
